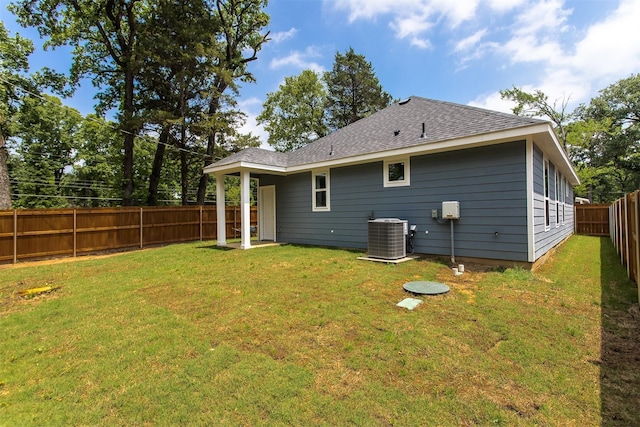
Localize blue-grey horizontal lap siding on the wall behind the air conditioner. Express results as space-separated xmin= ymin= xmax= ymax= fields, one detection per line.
xmin=260 ymin=142 xmax=527 ymax=261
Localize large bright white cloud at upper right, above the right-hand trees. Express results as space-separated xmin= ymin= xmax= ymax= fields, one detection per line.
xmin=471 ymin=0 xmax=640 ymax=111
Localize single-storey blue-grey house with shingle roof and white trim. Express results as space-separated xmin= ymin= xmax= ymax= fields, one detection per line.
xmin=204 ymin=96 xmax=579 ymax=264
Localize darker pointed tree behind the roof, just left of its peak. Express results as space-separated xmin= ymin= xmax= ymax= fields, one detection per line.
xmin=323 ymin=48 xmax=393 ymax=129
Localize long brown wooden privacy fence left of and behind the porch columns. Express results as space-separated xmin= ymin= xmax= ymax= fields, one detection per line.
xmin=0 ymin=206 xmax=258 ymax=264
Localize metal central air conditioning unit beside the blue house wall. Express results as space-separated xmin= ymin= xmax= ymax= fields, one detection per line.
xmin=367 ymin=218 xmax=407 ymax=260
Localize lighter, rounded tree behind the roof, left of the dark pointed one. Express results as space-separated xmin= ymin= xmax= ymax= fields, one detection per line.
xmin=257 ymin=70 xmax=328 ymax=152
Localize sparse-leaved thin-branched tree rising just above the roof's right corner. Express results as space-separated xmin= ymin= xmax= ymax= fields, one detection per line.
xmin=500 ymin=86 xmax=572 ymax=148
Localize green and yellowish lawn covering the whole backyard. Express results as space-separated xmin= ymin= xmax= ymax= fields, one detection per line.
xmin=0 ymin=236 xmax=640 ymax=426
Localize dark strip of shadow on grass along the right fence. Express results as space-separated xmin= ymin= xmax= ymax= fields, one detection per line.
xmin=600 ymin=237 xmax=640 ymax=426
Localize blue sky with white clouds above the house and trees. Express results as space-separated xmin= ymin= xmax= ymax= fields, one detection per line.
xmin=0 ymin=0 xmax=640 ymax=149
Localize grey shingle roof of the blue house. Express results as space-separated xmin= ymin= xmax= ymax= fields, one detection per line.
xmin=204 ymin=96 xmax=547 ymax=171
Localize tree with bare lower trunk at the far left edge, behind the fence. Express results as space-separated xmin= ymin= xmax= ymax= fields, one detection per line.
xmin=0 ymin=21 xmax=34 ymax=209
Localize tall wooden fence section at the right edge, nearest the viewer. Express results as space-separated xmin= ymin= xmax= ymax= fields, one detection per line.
xmin=609 ymin=191 xmax=640 ymax=299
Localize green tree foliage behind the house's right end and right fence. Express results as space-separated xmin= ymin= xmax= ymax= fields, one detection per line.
xmin=500 ymin=74 xmax=640 ymax=203
